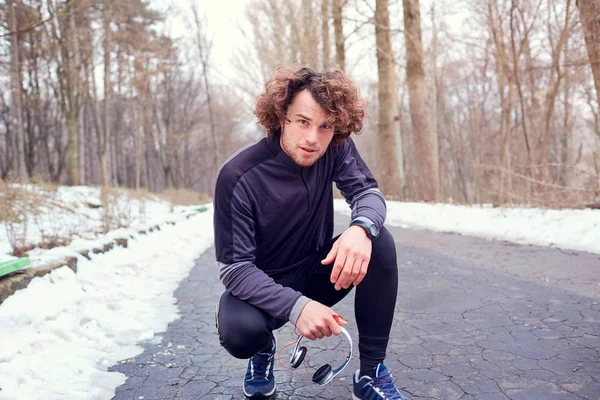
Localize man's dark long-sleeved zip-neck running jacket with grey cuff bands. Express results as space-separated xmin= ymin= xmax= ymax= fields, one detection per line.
xmin=214 ymin=137 xmax=386 ymax=325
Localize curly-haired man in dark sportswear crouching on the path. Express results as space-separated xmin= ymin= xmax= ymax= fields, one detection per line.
xmin=214 ymin=68 xmax=406 ymax=400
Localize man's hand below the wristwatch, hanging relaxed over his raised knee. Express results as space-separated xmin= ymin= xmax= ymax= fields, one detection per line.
xmin=321 ymin=226 xmax=373 ymax=290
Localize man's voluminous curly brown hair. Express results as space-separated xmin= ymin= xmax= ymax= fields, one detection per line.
xmin=254 ymin=67 xmax=365 ymax=144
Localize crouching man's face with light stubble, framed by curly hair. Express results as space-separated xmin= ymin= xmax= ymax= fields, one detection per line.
xmin=281 ymin=90 xmax=334 ymax=167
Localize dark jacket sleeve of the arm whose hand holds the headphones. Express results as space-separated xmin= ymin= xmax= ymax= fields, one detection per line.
xmin=213 ymin=171 xmax=309 ymax=325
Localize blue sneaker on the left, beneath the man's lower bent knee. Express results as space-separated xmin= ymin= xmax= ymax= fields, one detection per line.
xmin=244 ymin=333 xmax=277 ymax=399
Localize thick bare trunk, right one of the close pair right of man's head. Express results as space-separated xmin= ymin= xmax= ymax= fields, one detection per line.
xmin=403 ymin=0 xmax=439 ymax=201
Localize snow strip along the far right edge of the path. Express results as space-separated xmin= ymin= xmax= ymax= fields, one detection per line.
xmin=334 ymin=200 xmax=600 ymax=254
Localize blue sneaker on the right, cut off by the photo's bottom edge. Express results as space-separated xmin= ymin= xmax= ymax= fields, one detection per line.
xmin=352 ymin=364 xmax=408 ymax=400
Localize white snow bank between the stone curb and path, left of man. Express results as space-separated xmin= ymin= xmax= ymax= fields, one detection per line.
xmin=0 ymin=211 xmax=213 ymax=400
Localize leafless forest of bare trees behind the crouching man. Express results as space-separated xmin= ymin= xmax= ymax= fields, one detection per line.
xmin=0 ymin=0 xmax=600 ymax=207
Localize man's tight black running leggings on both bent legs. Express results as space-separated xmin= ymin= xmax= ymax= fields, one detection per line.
xmin=216 ymin=227 xmax=398 ymax=368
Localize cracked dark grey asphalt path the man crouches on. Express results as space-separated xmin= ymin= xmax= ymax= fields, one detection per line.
xmin=111 ymin=216 xmax=600 ymax=400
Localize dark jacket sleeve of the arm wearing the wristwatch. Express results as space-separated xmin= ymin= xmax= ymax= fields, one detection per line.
xmin=333 ymin=138 xmax=387 ymax=229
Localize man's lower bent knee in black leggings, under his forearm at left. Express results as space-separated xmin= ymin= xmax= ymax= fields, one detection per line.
xmin=216 ymin=293 xmax=271 ymax=359
